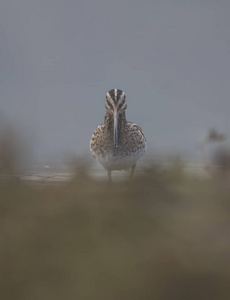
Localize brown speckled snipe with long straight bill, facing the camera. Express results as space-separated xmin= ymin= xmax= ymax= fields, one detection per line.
xmin=90 ymin=89 xmax=147 ymax=182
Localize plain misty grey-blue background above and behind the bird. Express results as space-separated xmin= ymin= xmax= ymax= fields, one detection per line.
xmin=0 ymin=0 xmax=230 ymax=161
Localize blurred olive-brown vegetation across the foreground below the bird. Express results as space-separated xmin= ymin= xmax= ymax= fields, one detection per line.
xmin=0 ymin=164 xmax=230 ymax=300
